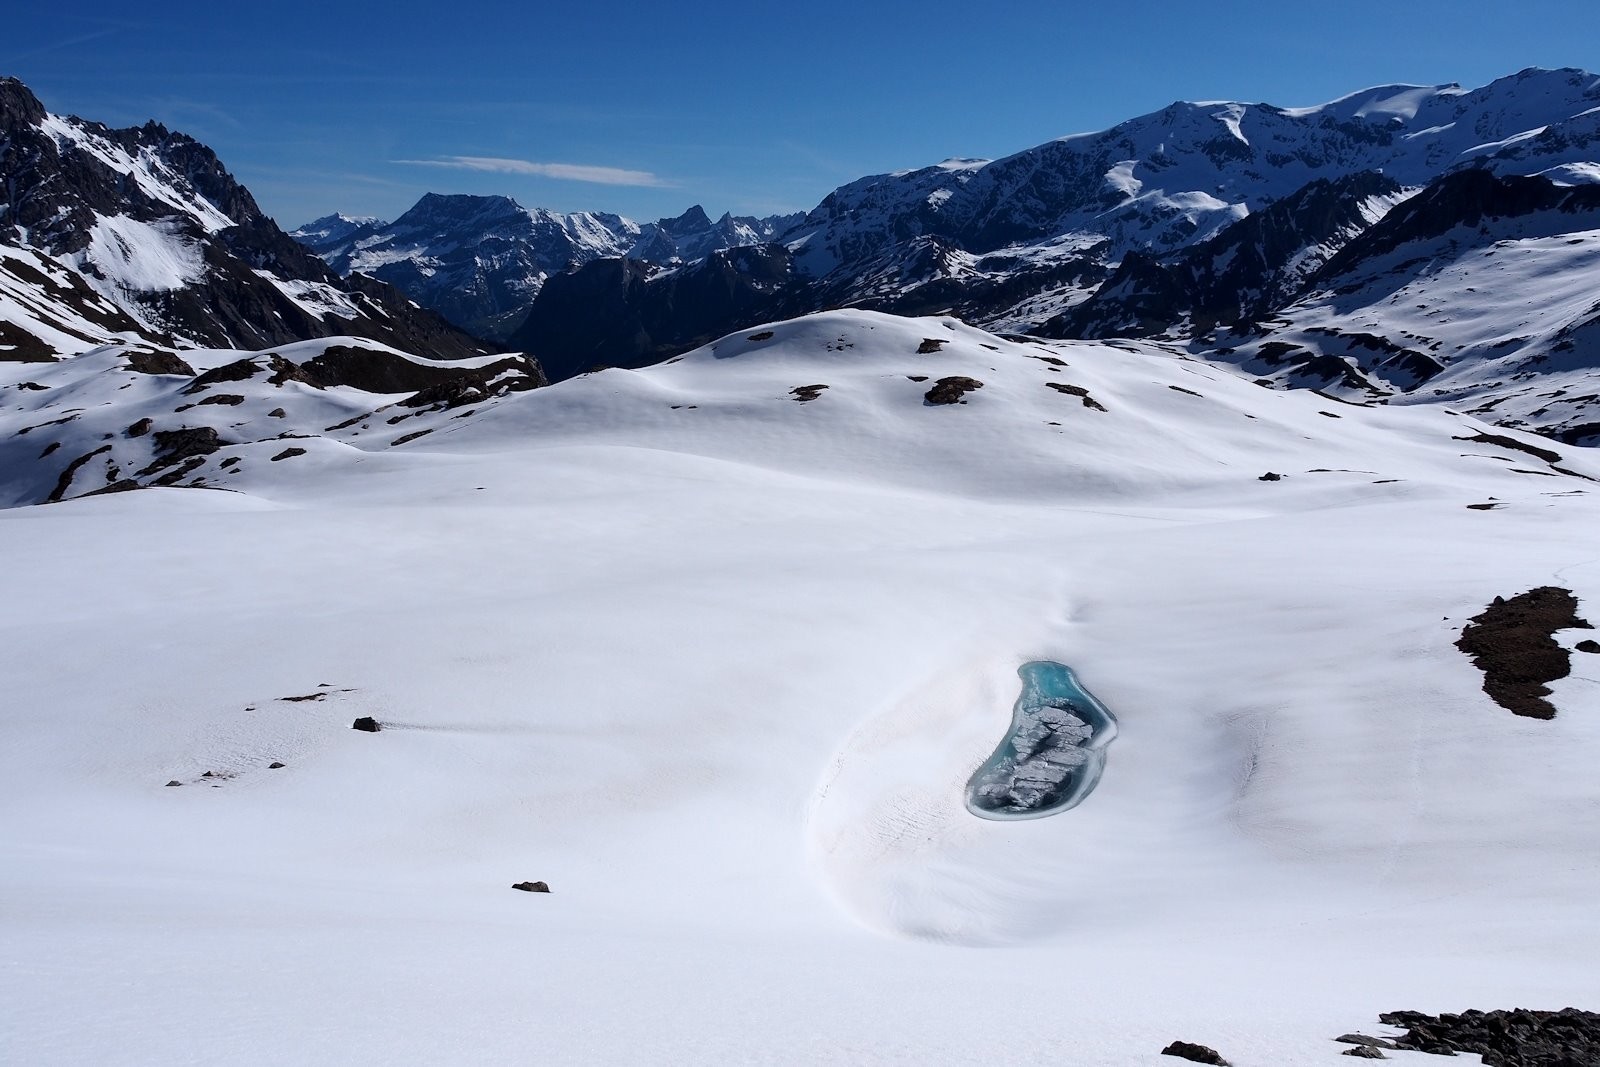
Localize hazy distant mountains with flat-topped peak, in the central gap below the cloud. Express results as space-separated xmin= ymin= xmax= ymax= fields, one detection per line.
xmin=291 ymin=194 xmax=797 ymax=341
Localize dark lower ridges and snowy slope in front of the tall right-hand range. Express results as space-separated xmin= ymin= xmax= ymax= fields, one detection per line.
xmin=1042 ymin=168 xmax=1600 ymax=443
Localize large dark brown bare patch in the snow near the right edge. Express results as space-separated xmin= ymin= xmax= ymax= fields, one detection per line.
xmin=1456 ymin=585 xmax=1594 ymax=718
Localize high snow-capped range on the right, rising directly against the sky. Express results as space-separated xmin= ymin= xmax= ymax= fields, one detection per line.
xmin=784 ymin=69 xmax=1600 ymax=267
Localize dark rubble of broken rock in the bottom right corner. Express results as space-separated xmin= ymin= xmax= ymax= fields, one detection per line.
xmin=1378 ymin=1008 xmax=1600 ymax=1067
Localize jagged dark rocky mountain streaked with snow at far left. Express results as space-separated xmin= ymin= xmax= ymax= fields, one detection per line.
xmin=0 ymin=78 xmax=482 ymax=360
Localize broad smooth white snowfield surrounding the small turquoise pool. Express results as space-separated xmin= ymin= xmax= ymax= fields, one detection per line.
xmin=0 ymin=312 xmax=1600 ymax=1067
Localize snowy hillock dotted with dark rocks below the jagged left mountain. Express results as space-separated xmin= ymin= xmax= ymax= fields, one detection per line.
xmin=0 ymin=338 xmax=544 ymax=507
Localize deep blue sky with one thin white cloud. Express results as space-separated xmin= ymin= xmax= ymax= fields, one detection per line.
xmin=0 ymin=0 xmax=1600 ymax=226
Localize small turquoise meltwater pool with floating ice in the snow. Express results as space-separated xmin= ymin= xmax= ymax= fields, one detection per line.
xmin=966 ymin=659 xmax=1117 ymax=819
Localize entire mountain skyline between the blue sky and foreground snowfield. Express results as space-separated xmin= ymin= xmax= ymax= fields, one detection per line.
xmin=0 ymin=69 xmax=1600 ymax=443
